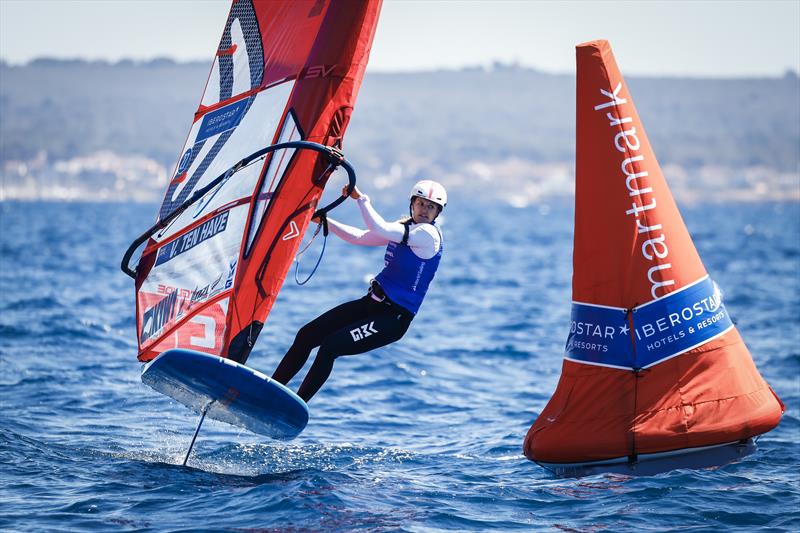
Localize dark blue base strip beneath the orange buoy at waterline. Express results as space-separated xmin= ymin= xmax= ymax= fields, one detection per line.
xmin=537 ymin=438 xmax=756 ymax=478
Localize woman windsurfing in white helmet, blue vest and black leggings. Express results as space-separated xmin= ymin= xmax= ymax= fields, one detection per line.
xmin=272 ymin=180 xmax=447 ymax=401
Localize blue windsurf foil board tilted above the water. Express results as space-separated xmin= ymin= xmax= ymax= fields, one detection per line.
xmin=142 ymin=349 xmax=308 ymax=440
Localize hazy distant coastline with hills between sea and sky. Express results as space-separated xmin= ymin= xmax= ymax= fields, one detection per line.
xmin=0 ymin=58 xmax=800 ymax=207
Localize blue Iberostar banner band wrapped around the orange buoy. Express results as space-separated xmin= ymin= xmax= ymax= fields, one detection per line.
xmin=566 ymin=277 xmax=733 ymax=368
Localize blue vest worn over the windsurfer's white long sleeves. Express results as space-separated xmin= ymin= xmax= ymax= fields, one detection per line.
xmin=375 ymin=223 xmax=444 ymax=314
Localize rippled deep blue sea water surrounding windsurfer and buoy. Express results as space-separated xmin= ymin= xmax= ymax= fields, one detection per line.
xmin=0 ymin=199 xmax=800 ymax=531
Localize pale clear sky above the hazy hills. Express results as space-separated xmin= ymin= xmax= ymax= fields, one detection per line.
xmin=0 ymin=0 xmax=800 ymax=77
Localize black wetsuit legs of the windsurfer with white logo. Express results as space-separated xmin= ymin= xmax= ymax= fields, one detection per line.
xmin=272 ymin=282 xmax=414 ymax=401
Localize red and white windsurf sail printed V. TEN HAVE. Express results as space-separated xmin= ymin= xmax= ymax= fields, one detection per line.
xmin=136 ymin=0 xmax=381 ymax=361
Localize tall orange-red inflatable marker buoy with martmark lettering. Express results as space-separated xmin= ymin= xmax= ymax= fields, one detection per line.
xmin=524 ymin=41 xmax=783 ymax=464
